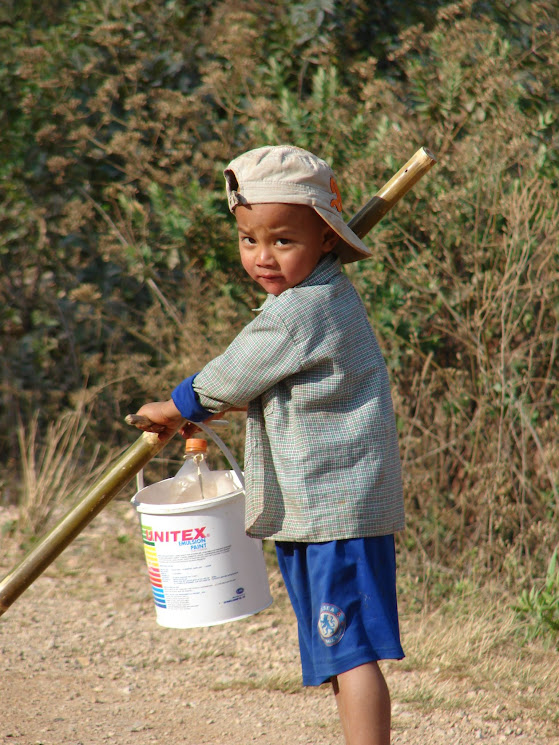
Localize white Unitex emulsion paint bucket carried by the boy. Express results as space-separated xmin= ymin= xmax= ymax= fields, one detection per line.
xmin=132 ymin=425 xmax=272 ymax=629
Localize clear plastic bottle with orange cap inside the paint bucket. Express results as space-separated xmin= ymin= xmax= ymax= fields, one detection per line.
xmin=172 ymin=438 xmax=236 ymax=503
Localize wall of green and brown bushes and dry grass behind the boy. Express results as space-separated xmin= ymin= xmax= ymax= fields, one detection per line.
xmin=0 ymin=0 xmax=559 ymax=643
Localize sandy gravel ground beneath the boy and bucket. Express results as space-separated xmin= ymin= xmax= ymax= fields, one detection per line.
xmin=0 ymin=502 xmax=559 ymax=745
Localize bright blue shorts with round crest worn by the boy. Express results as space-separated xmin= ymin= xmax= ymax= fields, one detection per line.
xmin=276 ymin=535 xmax=404 ymax=686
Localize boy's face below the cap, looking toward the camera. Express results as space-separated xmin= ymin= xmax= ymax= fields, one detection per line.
xmin=235 ymin=204 xmax=339 ymax=295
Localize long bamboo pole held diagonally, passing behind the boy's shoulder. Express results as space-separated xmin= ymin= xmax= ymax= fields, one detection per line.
xmin=0 ymin=148 xmax=436 ymax=616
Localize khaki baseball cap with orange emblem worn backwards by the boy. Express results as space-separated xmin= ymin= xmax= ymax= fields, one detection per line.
xmin=224 ymin=145 xmax=371 ymax=264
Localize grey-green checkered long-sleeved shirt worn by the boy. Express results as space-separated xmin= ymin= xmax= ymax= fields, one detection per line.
xmin=193 ymin=254 xmax=404 ymax=542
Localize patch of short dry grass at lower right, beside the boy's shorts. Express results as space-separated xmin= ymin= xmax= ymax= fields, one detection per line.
xmin=401 ymin=587 xmax=559 ymax=725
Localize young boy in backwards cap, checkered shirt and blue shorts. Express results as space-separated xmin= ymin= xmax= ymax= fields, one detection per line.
xmin=133 ymin=146 xmax=404 ymax=745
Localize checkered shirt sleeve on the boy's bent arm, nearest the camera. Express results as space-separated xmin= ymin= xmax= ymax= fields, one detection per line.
xmin=193 ymin=311 xmax=302 ymax=413
